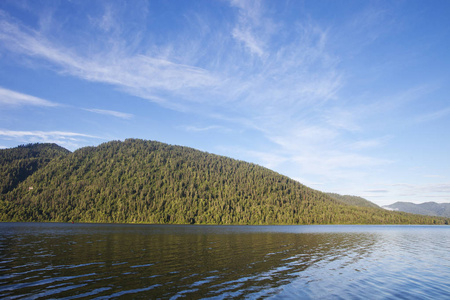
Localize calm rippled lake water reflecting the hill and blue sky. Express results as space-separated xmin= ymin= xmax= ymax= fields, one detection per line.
xmin=0 ymin=223 xmax=450 ymax=299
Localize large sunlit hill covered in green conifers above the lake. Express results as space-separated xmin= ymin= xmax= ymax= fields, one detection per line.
xmin=0 ymin=139 xmax=448 ymax=224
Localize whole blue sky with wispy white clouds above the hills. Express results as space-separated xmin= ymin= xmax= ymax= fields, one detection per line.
xmin=0 ymin=0 xmax=450 ymax=205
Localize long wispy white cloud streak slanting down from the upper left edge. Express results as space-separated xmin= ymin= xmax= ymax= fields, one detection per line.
xmin=0 ymin=11 xmax=219 ymax=111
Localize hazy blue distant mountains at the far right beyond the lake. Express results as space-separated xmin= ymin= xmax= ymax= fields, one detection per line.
xmin=383 ymin=202 xmax=450 ymax=217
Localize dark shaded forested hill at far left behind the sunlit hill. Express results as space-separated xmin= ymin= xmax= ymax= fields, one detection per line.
xmin=0 ymin=144 xmax=70 ymax=194
